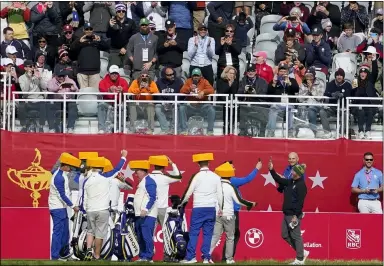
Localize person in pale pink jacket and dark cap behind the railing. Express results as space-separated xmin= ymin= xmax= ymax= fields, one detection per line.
xmin=47 ymin=66 xmax=79 ymax=133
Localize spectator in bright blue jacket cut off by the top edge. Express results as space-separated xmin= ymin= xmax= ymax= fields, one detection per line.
xmin=161 ymin=1 xmax=196 ymax=43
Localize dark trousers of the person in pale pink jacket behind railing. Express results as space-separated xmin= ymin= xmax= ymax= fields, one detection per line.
xmin=47 ymin=102 xmax=78 ymax=132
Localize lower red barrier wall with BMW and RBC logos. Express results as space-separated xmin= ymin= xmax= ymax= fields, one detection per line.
xmin=1 ymin=208 xmax=383 ymax=261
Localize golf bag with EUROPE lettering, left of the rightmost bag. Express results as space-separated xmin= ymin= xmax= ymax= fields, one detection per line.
xmin=113 ymin=194 xmax=140 ymax=261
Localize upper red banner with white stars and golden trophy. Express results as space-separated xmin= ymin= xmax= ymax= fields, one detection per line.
xmin=0 ymin=131 xmax=382 ymax=212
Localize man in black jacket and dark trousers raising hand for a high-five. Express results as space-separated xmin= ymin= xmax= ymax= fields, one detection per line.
xmin=268 ymin=157 xmax=309 ymax=265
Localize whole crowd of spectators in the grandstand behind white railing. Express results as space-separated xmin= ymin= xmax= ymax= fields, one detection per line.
xmin=0 ymin=1 xmax=383 ymax=139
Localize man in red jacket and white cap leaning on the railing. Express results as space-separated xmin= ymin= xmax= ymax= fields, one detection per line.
xmin=97 ymin=65 xmax=128 ymax=134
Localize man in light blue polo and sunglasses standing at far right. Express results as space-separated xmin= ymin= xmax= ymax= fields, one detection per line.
xmin=352 ymin=152 xmax=383 ymax=214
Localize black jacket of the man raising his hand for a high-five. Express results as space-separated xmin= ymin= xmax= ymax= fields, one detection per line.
xmin=269 ymin=169 xmax=307 ymax=217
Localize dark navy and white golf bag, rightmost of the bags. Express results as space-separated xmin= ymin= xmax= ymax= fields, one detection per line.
xmin=162 ymin=195 xmax=189 ymax=262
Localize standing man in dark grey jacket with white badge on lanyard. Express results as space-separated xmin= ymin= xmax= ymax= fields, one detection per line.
xmin=127 ymin=18 xmax=158 ymax=80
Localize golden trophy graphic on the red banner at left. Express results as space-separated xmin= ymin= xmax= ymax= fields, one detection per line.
xmin=7 ymin=149 xmax=52 ymax=208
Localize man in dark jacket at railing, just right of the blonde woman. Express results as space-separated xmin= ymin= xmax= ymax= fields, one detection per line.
xmin=238 ymin=64 xmax=269 ymax=137
